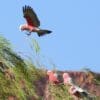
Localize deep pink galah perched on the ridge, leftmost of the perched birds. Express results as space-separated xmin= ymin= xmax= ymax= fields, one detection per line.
xmin=47 ymin=71 xmax=59 ymax=84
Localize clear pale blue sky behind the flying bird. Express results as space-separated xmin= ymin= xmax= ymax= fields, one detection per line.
xmin=0 ymin=0 xmax=100 ymax=72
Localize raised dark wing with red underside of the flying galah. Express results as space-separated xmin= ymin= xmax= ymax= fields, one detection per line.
xmin=23 ymin=6 xmax=40 ymax=27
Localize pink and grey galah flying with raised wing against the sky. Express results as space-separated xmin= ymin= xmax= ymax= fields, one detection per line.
xmin=20 ymin=6 xmax=52 ymax=36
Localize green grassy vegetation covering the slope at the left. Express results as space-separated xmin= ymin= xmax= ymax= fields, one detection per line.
xmin=0 ymin=36 xmax=44 ymax=100
